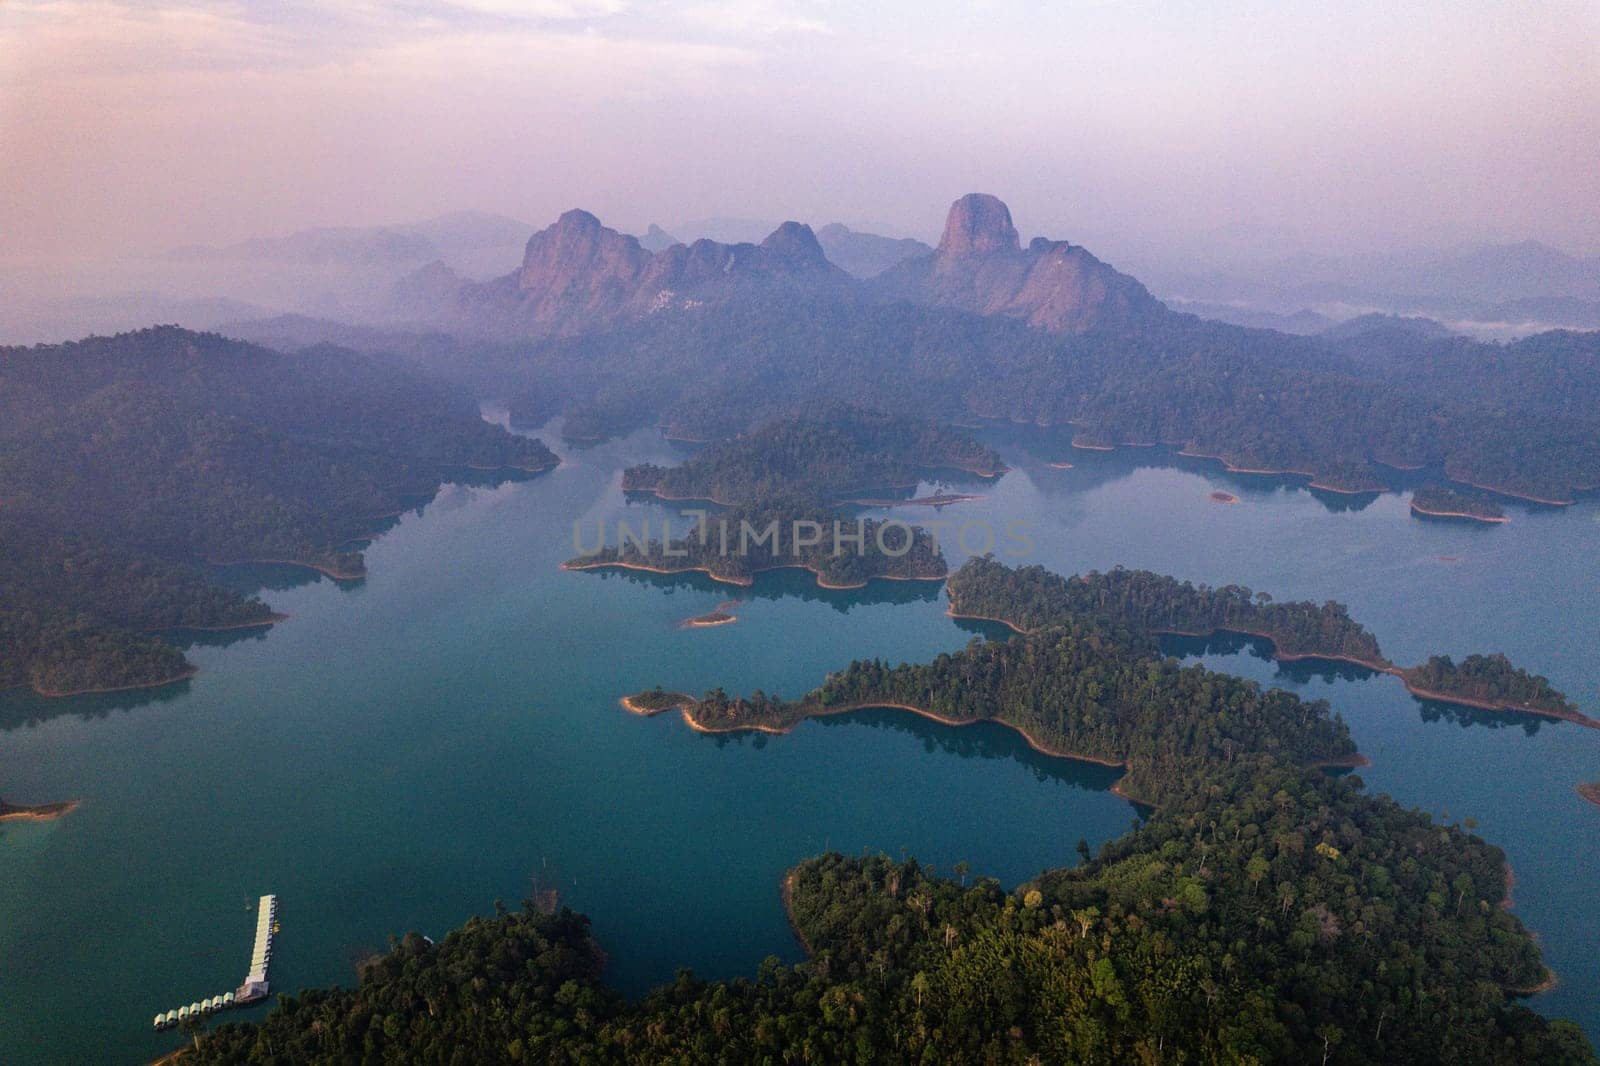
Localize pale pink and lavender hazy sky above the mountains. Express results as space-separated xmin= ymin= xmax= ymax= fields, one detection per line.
xmin=0 ymin=0 xmax=1600 ymax=254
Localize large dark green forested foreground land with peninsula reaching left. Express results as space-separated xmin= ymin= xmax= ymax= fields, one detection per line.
xmin=184 ymin=560 xmax=1595 ymax=1066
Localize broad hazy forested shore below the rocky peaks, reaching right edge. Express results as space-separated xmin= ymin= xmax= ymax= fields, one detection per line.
xmin=507 ymin=295 xmax=1600 ymax=499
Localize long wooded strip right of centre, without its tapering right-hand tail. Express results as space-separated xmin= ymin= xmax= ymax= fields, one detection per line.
xmin=949 ymin=555 xmax=1387 ymax=667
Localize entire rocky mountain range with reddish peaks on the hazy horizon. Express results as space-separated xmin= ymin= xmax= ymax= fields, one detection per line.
xmin=392 ymin=194 xmax=1168 ymax=336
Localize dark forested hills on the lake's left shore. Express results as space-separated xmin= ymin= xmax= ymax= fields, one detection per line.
xmin=0 ymin=327 xmax=557 ymax=695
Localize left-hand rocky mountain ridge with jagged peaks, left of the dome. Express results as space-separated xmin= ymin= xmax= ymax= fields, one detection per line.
xmin=448 ymin=211 xmax=848 ymax=335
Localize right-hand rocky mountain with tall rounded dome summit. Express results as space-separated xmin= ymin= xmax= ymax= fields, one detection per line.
xmin=877 ymin=194 xmax=1166 ymax=333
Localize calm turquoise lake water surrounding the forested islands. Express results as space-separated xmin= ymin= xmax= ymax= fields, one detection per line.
xmin=0 ymin=419 xmax=1600 ymax=1063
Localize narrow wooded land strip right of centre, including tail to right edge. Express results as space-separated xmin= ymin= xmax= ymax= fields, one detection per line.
xmin=947 ymin=555 xmax=1600 ymax=727
